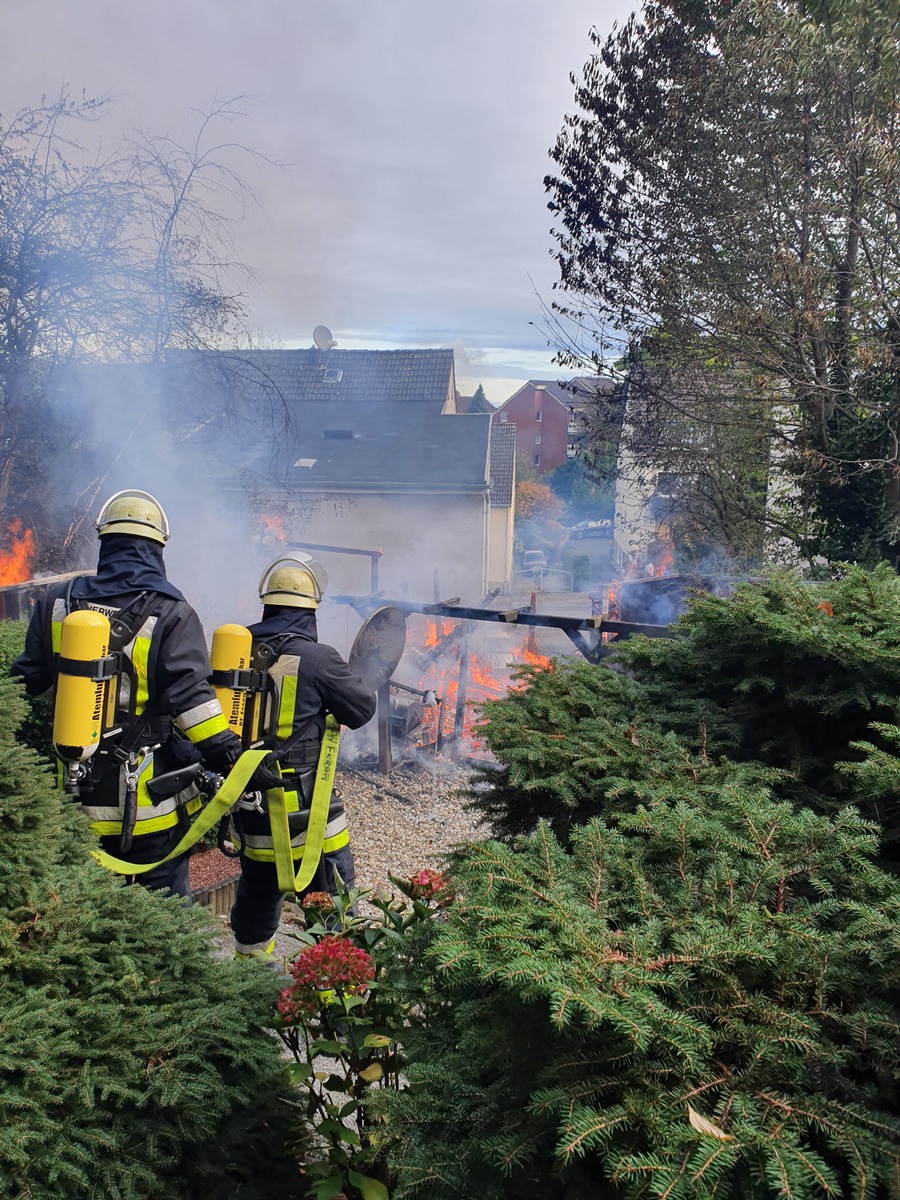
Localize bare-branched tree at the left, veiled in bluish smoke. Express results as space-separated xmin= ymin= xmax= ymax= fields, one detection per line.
xmin=0 ymin=92 xmax=262 ymax=566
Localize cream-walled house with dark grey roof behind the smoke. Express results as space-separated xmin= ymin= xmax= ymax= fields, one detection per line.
xmin=170 ymin=349 xmax=515 ymax=602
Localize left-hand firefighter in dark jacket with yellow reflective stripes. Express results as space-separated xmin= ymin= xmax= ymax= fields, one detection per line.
xmin=12 ymin=491 xmax=240 ymax=896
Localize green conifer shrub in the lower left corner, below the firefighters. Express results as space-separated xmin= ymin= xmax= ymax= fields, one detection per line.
xmin=0 ymin=662 xmax=301 ymax=1200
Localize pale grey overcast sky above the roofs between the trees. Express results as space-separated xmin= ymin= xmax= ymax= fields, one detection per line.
xmin=0 ymin=0 xmax=634 ymax=403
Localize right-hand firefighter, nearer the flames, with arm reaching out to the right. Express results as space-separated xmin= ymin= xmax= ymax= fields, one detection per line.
xmin=232 ymin=554 xmax=376 ymax=955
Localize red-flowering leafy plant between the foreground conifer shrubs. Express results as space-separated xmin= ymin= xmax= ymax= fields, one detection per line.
xmin=274 ymin=869 xmax=454 ymax=1200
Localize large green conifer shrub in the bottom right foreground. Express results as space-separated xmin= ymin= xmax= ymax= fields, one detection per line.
xmin=378 ymin=782 xmax=900 ymax=1200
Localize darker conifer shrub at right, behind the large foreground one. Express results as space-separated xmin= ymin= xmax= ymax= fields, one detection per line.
xmin=470 ymin=568 xmax=900 ymax=857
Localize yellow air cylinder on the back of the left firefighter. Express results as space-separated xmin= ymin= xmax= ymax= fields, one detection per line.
xmin=53 ymin=610 xmax=109 ymax=762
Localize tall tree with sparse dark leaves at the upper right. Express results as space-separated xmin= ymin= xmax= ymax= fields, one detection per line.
xmin=546 ymin=0 xmax=900 ymax=562
